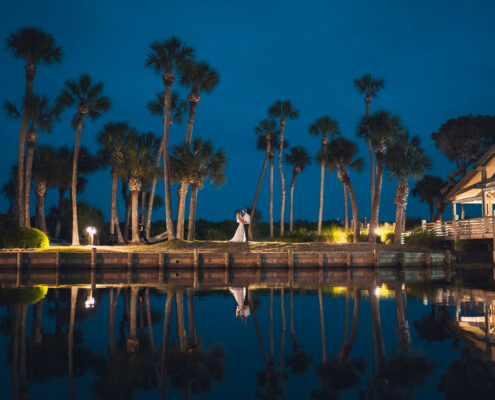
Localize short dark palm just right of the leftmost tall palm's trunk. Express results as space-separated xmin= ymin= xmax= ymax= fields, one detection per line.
xmin=33 ymin=145 xmax=57 ymax=233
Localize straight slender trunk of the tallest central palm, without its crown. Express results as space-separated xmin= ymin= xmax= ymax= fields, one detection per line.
xmin=163 ymin=83 xmax=175 ymax=240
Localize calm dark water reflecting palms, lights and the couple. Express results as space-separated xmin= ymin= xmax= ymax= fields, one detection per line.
xmin=0 ymin=269 xmax=495 ymax=400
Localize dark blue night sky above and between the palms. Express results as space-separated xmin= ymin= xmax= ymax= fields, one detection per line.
xmin=0 ymin=0 xmax=495 ymax=221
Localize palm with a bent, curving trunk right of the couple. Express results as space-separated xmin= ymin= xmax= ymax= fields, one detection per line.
xmin=319 ymin=137 xmax=363 ymax=243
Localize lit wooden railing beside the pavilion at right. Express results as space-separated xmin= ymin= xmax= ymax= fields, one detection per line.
xmin=421 ymin=216 xmax=494 ymax=240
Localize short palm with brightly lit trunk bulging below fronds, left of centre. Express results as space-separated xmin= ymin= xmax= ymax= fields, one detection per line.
xmin=121 ymin=129 xmax=160 ymax=243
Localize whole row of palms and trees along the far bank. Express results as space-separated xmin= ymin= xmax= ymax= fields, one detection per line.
xmin=2 ymin=27 xmax=495 ymax=245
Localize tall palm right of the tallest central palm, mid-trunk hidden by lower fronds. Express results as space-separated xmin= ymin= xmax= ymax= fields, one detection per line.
xmin=177 ymin=61 xmax=219 ymax=239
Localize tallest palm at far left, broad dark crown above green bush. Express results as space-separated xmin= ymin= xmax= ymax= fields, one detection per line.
xmin=6 ymin=26 xmax=63 ymax=226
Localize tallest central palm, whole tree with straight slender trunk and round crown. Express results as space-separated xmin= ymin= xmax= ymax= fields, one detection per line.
xmin=146 ymin=37 xmax=193 ymax=239
